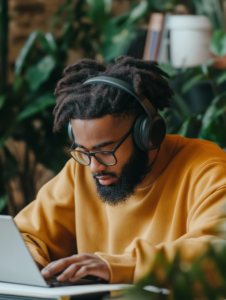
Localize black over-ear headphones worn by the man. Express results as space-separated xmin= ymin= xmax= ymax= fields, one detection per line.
xmin=68 ymin=76 xmax=166 ymax=151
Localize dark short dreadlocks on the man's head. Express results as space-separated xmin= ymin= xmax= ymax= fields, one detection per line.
xmin=53 ymin=56 xmax=174 ymax=132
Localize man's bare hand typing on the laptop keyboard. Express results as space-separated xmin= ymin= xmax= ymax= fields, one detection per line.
xmin=41 ymin=254 xmax=110 ymax=282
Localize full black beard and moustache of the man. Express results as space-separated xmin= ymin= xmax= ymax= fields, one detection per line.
xmin=93 ymin=145 xmax=149 ymax=206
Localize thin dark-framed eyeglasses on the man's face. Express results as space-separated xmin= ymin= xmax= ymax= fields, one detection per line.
xmin=68 ymin=127 xmax=133 ymax=166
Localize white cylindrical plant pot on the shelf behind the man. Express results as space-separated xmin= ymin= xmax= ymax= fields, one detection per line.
xmin=168 ymin=15 xmax=213 ymax=68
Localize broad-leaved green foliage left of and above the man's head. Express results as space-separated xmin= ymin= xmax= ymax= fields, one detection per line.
xmin=0 ymin=0 xmax=154 ymax=215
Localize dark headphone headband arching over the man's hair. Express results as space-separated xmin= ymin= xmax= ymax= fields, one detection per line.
xmin=83 ymin=76 xmax=157 ymax=118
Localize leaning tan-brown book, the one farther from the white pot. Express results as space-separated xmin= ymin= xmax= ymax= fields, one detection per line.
xmin=143 ymin=13 xmax=165 ymax=60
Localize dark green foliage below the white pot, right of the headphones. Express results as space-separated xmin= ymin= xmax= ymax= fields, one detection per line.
xmin=159 ymin=63 xmax=226 ymax=148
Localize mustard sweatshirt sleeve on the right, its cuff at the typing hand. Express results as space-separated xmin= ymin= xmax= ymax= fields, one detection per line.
xmin=96 ymin=162 xmax=226 ymax=283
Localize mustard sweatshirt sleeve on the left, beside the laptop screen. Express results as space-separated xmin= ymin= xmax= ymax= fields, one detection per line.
xmin=15 ymin=160 xmax=77 ymax=267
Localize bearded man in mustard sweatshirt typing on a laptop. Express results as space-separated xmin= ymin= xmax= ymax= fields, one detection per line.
xmin=15 ymin=56 xmax=226 ymax=283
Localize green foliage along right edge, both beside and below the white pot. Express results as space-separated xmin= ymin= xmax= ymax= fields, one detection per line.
xmin=157 ymin=0 xmax=226 ymax=148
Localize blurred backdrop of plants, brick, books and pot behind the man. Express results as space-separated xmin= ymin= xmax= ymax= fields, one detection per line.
xmin=0 ymin=0 xmax=226 ymax=216
